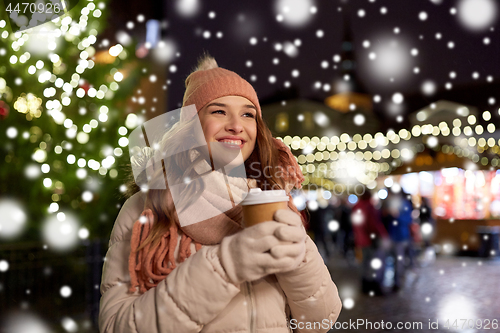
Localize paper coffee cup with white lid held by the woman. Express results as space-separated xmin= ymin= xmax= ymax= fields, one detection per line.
xmin=241 ymin=188 xmax=289 ymax=227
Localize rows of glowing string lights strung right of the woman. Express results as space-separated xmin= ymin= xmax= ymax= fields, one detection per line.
xmin=290 ymin=107 xmax=500 ymax=185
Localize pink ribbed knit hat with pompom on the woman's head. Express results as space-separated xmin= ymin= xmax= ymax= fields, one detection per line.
xmin=181 ymin=56 xmax=262 ymax=120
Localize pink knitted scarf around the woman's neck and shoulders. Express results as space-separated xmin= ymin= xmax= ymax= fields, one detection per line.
xmin=129 ymin=139 xmax=304 ymax=293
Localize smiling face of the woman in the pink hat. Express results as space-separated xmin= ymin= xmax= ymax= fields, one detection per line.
xmin=198 ymin=96 xmax=258 ymax=161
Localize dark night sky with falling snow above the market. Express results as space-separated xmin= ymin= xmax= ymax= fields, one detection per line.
xmin=159 ymin=0 xmax=500 ymax=122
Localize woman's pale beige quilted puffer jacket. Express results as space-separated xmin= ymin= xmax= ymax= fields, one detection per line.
xmin=99 ymin=192 xmax=341 ymax=333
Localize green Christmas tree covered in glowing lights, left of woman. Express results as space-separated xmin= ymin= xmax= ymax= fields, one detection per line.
xmin=0 ymin=0 xmax=143 ymax=250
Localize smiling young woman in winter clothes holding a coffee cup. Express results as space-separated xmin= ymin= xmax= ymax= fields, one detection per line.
xmin=99 ymin=56 xmax=341 ymax=333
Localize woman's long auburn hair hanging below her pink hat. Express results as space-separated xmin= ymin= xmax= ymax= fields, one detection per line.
xmin=125 ymin=110 xmax=300 ymax=249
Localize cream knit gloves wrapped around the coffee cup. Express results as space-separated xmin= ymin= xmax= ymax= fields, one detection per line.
xmin=219 ymin=214 xmax=305 ymax=285
